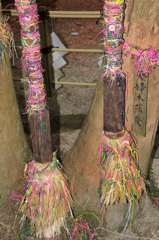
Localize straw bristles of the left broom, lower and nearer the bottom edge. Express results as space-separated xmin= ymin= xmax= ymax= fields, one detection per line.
xmin=20 ymin=154 xmax=72 ymax=238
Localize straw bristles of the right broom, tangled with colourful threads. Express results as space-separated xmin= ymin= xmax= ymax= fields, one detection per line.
xmin=100 ymin=131 xmax=146 ymax=209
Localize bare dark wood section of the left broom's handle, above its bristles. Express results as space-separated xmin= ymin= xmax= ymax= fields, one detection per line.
xmin=30 ymin=110 xmax=52 ymax=163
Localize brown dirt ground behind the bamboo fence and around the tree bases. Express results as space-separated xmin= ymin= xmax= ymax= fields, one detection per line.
xmin=0 ymin=0 xmax=159 ymax=240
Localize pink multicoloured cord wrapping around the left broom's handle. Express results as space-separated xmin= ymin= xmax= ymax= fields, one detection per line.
xmin=15 ymin=0 xmax=46 ymax=112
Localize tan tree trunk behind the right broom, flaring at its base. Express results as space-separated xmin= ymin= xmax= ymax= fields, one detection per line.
xmin=63 ymin=0 xmax=159 ymax=233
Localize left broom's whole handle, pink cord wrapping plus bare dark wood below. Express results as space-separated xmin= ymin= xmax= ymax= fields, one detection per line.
xmin=15 ymin=0 xmax=52 ymax=163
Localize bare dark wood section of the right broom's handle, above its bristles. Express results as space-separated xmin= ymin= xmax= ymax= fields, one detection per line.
xmin=103 ymin=78 xmax=126 ymax=133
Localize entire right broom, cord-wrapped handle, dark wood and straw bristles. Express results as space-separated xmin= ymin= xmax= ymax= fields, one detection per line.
xmin=100 ymin=0 xmax=146 ymax=212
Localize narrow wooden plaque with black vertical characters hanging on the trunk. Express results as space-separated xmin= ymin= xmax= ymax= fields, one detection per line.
xmin=132 ymin=71 xmax=148 ymax=137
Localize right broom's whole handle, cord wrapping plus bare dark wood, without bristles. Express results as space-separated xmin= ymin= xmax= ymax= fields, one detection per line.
xmin=103 ymin=0 xmax=126 ymax=134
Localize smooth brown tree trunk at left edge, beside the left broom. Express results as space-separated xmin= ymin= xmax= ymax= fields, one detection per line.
xmin=0 ymin=1 xmax=32 ymax=203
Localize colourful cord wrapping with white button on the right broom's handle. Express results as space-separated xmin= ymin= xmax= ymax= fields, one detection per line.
xmin=102 ymin=0 xmax=125 ymax=82
